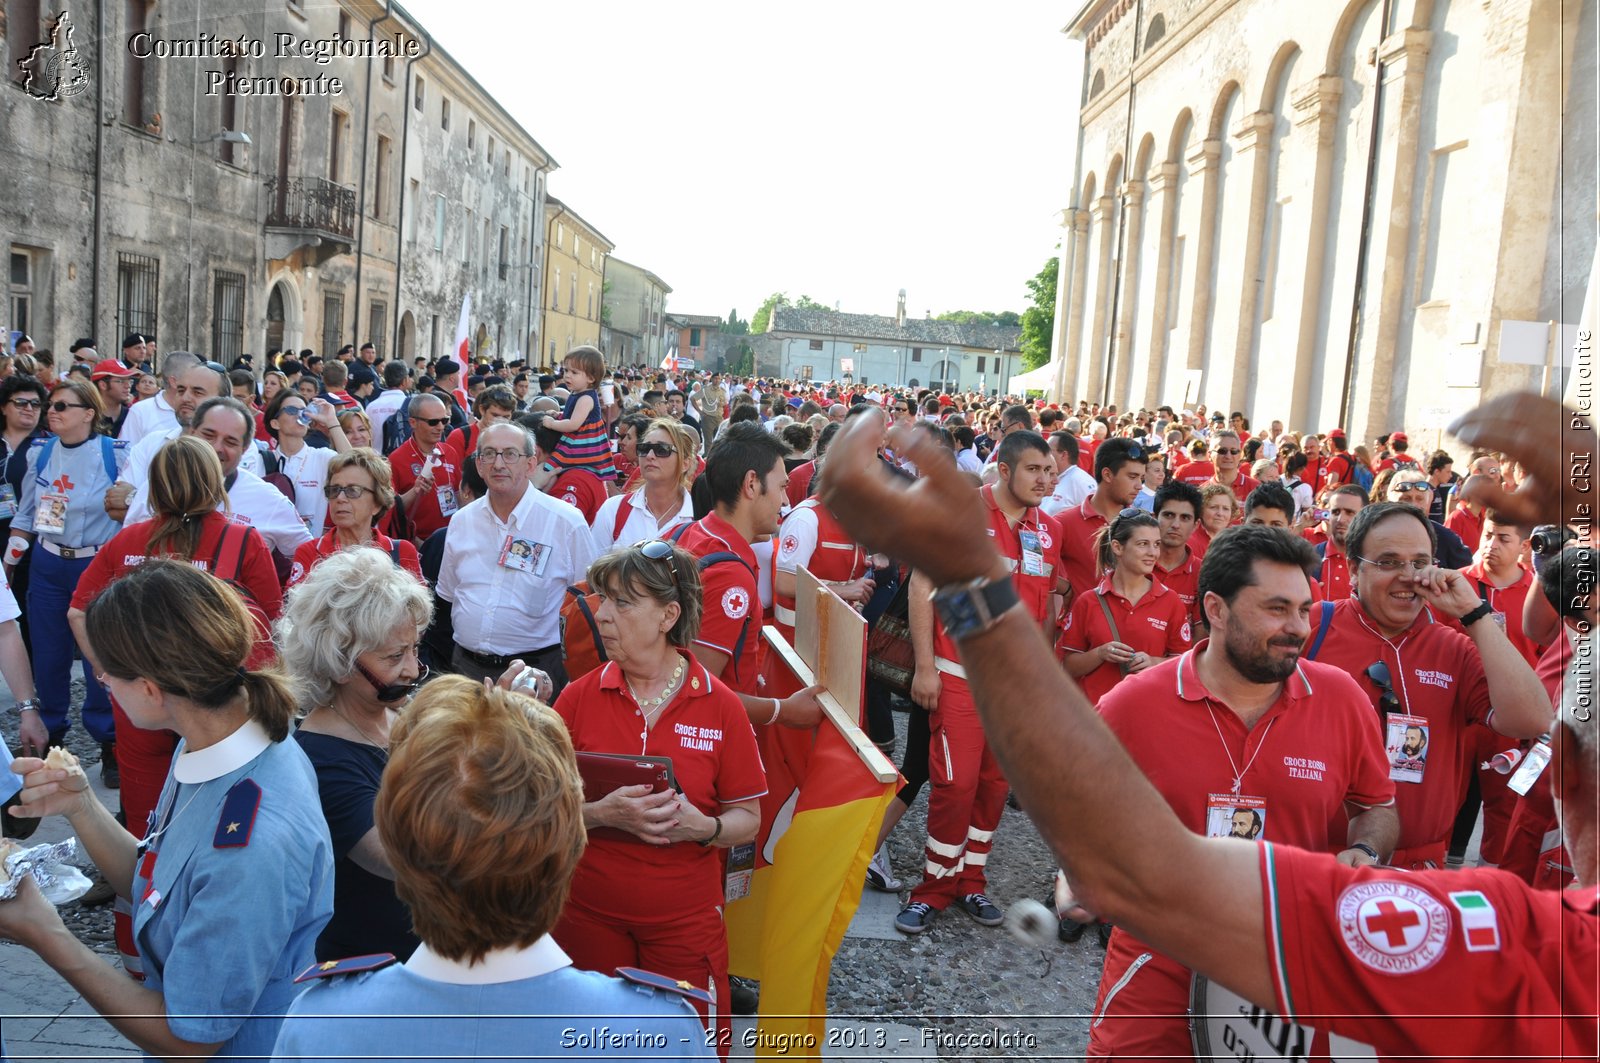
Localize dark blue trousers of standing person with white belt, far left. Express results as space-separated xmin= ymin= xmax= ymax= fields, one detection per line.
xmin=27 ymin=544 xmax=117 ymax=743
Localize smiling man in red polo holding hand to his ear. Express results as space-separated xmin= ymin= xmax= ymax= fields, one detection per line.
xmin=1306 ymin=503 xmax=1550 ymax=868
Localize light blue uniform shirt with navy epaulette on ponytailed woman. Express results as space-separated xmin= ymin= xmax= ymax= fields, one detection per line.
xmin=128 ymin=722 xmax=333 ymax=1058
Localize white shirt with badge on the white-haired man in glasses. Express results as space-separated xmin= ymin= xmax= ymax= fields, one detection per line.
xmin=435 ymin=485 xmax=595 ymax=656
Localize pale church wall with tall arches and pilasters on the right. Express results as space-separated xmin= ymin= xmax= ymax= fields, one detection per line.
xmin=1053 ymin=0 xmax=1597 ymax=437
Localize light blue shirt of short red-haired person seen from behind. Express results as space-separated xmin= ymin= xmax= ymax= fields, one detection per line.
xmin=274 ymin=935 xmax=714 ymax=1063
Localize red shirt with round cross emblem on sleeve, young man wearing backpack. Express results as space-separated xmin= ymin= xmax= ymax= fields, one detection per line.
xmin=678 ymin=512 xmax=762 ymax=695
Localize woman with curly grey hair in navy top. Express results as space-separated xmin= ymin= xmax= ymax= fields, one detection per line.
xmin=277 ymin=546 xmax=434 ymax=961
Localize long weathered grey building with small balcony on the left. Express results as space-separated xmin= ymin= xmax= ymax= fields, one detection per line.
xmin=0 ymin=0 xmax=555 ymax=369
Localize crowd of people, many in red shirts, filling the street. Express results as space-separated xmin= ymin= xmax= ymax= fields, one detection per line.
xmin=0 ymin=335 xmax=1597 ymax=1058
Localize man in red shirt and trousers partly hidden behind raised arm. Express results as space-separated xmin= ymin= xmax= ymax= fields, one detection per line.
xmin=896 ymin=429 xmax=1068 ymax=933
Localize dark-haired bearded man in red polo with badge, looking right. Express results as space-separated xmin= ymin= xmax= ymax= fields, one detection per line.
xmin=1090 ymin=525 xmax=1400 ymax=1058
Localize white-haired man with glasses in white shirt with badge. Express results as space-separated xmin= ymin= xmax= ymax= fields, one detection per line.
xmin=435 ymin=423 xmax=595 ymax=688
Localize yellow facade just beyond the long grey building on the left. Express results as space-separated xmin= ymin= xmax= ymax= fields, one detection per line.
xmin=534 ymin=195 xmax=614 ymax=367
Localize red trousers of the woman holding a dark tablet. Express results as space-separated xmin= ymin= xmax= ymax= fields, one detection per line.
xmin=552 ymin=884 xmax=733 ymax=1058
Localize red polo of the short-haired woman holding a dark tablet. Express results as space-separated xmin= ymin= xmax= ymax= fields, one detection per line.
xmin=555 ymin=653 xmax=766 ymax=906
